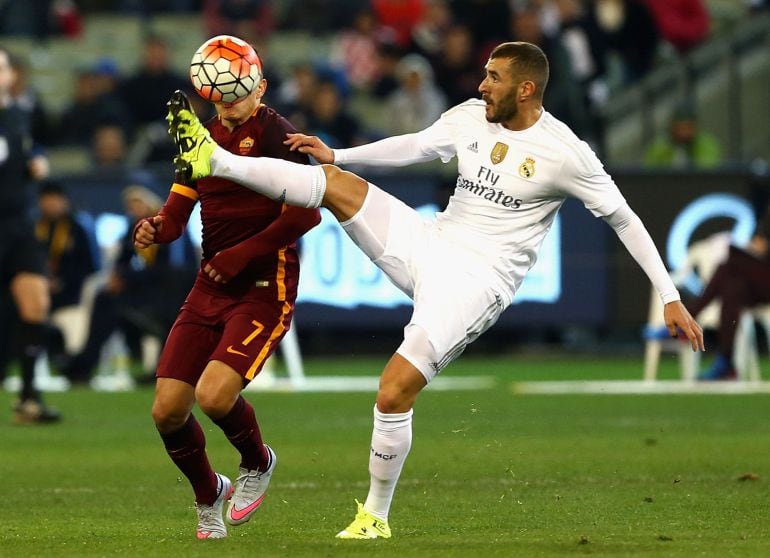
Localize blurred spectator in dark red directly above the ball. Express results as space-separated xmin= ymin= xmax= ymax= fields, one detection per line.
xmin=202 ymin=0 xmax=275 ymax=43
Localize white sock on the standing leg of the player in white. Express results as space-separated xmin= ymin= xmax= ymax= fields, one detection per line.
xmin=364 ymin=405 xmax=413 ymax=521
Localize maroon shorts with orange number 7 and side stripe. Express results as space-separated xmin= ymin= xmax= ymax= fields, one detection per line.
xmin=157 ymin=287 xmax=294 ymax=386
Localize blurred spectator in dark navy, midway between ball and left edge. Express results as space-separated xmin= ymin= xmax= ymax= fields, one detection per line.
xmin=57 ymin=59 xmax=131 ymax=147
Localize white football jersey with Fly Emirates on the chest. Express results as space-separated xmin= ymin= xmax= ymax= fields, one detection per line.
xmin=416 ymin=99 xmax=625 ymax=302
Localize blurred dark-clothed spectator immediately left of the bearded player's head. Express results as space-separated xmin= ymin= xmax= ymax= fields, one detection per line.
xmin=432 ymin=24 xmax=479 ymax=106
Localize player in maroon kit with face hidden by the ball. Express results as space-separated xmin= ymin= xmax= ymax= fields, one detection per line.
xmin=134 ymin=55 xmax=320 ymax=539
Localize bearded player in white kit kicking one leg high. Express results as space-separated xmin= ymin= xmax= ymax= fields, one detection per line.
xmin=168 ymin=42 xmax=704 ymax=539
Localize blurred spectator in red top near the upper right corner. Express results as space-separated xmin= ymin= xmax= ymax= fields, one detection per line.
xmin=644 ymin=0 xmax=711 ymax=53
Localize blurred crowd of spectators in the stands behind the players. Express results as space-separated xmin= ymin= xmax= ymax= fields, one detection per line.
xmin=0 ymin=0 xmax=768 ymax=171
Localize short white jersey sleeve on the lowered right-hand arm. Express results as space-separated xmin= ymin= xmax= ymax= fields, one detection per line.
xmin=557 ymin=141 xmax=626 ymax=217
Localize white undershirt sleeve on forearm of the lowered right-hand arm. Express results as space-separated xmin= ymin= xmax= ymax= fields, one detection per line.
xmin=604 ymin=203 xmax=680 ymax=304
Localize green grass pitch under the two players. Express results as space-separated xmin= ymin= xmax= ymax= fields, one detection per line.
xmin=0 ymin=355 xmax=770 ymax=558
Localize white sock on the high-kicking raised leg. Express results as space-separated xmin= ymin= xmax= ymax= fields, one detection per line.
xmin=211 ymin=147 xmax=326 ymax=207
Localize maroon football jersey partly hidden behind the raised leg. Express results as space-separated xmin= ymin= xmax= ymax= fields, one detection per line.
xmin=195 ymin=105 xmax=309 ymax=300
